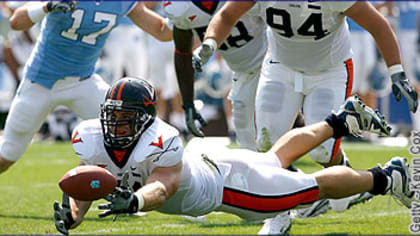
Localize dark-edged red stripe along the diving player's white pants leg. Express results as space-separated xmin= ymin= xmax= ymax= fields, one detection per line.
xmin=223 ymin=186 xmax=319 ymax=212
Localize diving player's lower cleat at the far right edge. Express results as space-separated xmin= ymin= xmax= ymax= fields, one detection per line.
xmin=382 ymin=157 xmax=414 ymax=208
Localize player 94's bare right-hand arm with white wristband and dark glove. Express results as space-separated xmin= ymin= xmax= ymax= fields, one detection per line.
xmin=344 ymin=1 xmax=418 ymax=113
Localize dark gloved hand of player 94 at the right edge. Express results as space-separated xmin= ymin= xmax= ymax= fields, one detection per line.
xmin=391 ymin=71 xmax=418 ymax=113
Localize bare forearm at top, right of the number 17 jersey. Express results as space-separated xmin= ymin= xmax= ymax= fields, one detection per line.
xmin=128 ymin=2 xmax=172 ymax=41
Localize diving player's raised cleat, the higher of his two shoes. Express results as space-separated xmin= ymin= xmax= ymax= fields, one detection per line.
xmin=335 ymin=96 xmax=391 ymax=137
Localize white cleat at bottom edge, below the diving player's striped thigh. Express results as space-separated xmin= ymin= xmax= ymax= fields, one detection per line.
xmin=258 ymin=211 xmax=292 ymax=235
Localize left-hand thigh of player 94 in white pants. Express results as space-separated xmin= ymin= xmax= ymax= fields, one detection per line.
xmin=255 ymin=65 xmax=303 ymax=145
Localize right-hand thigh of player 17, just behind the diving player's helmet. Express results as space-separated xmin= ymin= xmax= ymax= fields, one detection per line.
xmin=68 ymin=74 xmax=109 ymax=120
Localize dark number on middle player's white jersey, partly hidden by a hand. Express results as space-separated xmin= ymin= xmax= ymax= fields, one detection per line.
xmin=194 ymin=21 xmax=254 ymax=50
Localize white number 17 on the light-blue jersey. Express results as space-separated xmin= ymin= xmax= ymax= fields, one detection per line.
xmin=61 ymin=9 xmax=117 ymax=45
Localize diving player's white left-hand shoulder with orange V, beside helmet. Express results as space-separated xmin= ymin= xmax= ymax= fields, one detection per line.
xmin=71 ymin=119 xmax=103 ymax=161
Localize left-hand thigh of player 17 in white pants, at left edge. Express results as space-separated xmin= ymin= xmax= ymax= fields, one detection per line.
xmin=0 ymin=79 xmax=52 ymax=161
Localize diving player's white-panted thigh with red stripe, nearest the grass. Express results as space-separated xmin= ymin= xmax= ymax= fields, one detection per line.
xmin=222 ymin=152 xmax=319 ymax=220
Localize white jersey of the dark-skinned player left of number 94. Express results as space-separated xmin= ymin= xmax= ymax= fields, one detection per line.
xmin=163 ymin=1 xmax=267 ymax=72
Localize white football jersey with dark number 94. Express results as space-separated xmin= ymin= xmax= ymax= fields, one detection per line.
xmin=254 ymin=1 xmax=355 ymax=72
